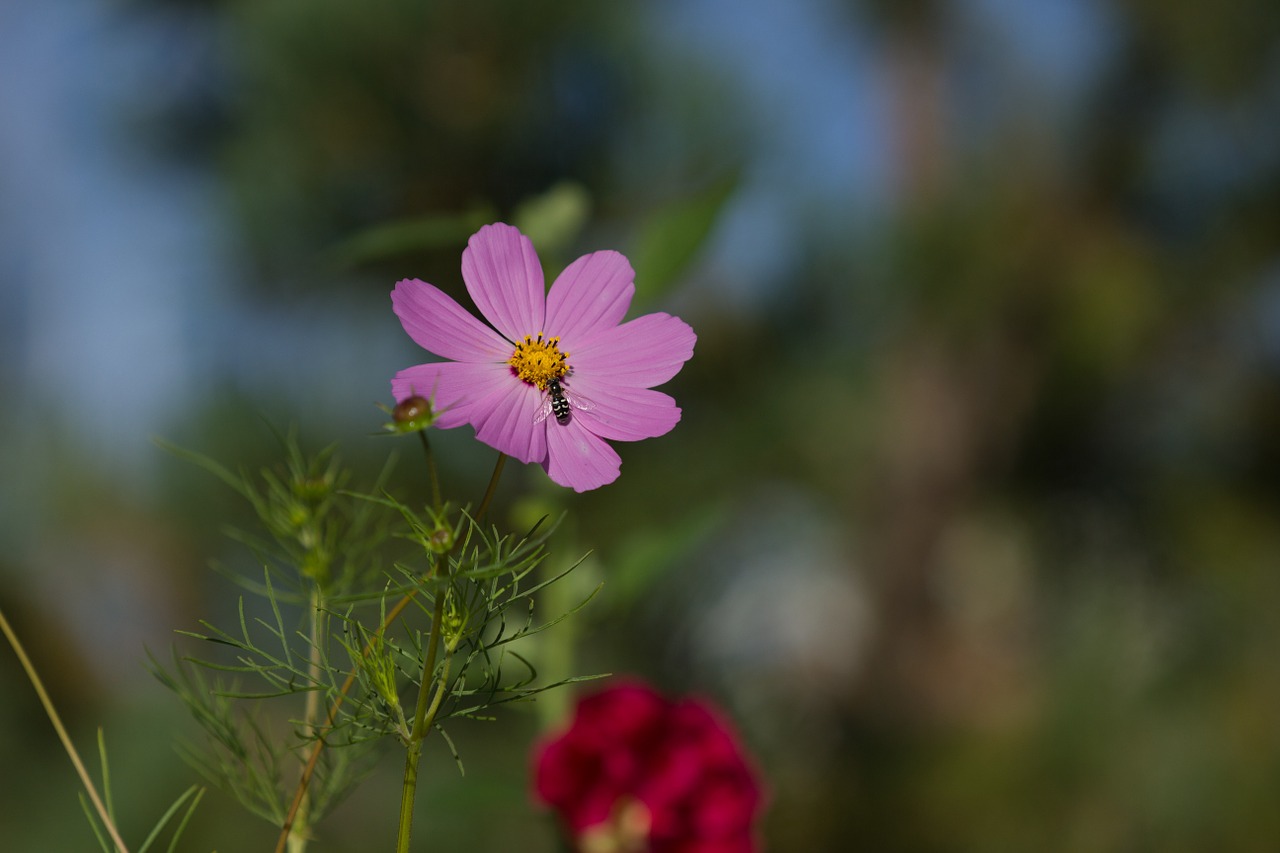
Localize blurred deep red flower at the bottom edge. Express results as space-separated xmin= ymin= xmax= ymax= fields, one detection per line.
xmin=534 ymin=683 xmax=763 ymax=853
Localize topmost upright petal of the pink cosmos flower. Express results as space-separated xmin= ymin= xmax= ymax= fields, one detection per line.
xmin=462 ymin=223 xmax=547 ymax=341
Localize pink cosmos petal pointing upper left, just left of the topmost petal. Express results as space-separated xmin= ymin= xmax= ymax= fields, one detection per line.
xmin=392 ymin=278 xmax=511 ymax=361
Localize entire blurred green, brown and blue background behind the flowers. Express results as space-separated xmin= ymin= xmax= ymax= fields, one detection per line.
xmin=0 ymin=0 xmax=1280 ymax=852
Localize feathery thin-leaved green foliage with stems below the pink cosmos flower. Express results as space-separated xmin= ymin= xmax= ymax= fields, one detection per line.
xmin=152 ymin=434 xmax=594 ymax=834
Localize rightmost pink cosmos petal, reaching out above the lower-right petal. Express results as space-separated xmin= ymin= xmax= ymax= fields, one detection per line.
xmin=570 ymin=314 xmax=698 ymax=388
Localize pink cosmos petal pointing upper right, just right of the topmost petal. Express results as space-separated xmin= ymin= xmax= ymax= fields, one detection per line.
xmin=547 ymin=251 xmax=636 ymax=353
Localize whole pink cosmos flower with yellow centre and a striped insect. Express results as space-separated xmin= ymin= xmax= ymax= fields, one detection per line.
xmin=392 ymin=223 xmax=696 ymax=492
